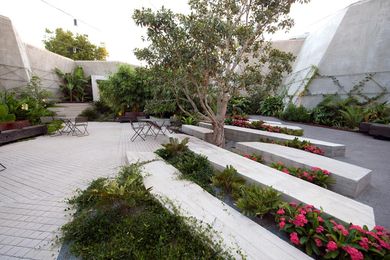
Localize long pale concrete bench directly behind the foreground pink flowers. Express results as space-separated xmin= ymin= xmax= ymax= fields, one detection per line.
xmin=170 ymin=134 xmax=375 ymax=228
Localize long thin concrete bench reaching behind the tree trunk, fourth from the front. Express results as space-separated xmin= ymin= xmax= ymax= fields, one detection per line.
xmin=199 ymin=123 xmax=345 ymax=157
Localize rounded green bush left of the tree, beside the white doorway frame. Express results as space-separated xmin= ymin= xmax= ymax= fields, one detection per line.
xmin=99 ymin=65 xmax=151 ymax=114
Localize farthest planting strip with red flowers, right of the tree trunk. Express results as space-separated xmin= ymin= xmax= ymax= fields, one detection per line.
xmin=225 ymin=115 xmax=303 ymax=136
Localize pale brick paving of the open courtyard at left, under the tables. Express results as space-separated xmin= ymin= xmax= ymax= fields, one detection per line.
xmin=0 ymin=122 xmax=160 ymax=259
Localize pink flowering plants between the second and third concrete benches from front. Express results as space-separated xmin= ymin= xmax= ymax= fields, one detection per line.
xmin=271 ymin=162 xmax=335 ymax=188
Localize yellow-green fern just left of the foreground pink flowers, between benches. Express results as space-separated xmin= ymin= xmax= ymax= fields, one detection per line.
xmin=237 ymin=184 xmax=281 ymax=217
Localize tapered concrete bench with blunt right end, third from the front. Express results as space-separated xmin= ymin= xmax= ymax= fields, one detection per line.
xmin=235 ymin=142 xmax=371 ymax=198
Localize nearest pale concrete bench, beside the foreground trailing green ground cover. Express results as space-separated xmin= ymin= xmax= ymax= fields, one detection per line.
xmin=127 ymin=152 xmax=311 ymax=260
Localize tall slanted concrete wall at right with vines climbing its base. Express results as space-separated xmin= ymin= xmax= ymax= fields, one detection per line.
xmin=285 ymin=0 xmax=390 ymax=107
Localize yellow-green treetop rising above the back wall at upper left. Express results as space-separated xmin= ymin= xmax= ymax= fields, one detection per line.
xmin=43 ymin=28 xmax=108 ymax=60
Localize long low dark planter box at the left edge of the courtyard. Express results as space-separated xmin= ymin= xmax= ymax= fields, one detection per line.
xmin=0 ymin=125 xmax=47 ymax=145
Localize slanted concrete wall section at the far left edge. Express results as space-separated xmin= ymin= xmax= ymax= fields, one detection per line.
xmin=0 ymin=15 xmax=31 ymax=89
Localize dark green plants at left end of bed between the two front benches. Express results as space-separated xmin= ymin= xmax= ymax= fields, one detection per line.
xmin=156 ymin=138 xmax=214 ymax=193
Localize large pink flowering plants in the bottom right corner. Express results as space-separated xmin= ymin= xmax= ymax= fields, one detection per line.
xmin=275 ymin=203 xmax=390 ymax=260
